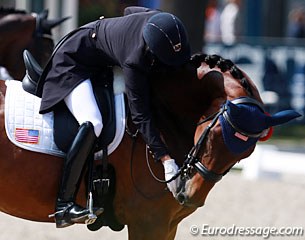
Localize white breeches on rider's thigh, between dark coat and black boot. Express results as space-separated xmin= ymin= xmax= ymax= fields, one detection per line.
xmin=64 ymin=79 xmax=103 ymax=137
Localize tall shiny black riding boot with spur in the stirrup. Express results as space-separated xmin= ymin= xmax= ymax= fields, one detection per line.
xmin=55 ymin=122 xmax=103 ymax=228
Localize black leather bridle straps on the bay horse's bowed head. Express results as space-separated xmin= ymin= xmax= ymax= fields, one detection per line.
xmin=177 ymin=97 xmax=265 ymax=182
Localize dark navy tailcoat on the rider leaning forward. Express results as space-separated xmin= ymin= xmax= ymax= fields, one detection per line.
xmin=40 ymin=7 xmax=167 ymax=158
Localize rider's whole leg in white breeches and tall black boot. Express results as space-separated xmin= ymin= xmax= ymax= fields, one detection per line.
xmin=55 ymin=80 xmax=103 ymax=228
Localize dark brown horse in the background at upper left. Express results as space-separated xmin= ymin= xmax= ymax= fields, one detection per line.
xmin=0 ymin=7 xmax=68 ymax=80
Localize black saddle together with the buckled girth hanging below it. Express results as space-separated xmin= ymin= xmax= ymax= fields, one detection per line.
xmin=22 ymin=50 xmax=124 ymax=231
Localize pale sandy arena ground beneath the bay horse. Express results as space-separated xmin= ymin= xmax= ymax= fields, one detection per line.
xmin=0 ymin=171 xmax=305 ymax=240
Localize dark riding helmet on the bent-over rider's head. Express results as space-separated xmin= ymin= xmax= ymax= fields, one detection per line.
xmin=143 ymin=13 xmax=190 ymax=66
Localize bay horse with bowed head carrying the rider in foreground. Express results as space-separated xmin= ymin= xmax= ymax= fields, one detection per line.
xmin=0 ymin=54 xmax=296 ymax=240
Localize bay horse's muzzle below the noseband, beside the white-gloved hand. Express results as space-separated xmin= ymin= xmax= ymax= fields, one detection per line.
xmin=175 ymin=173 xmax=215 ymax=208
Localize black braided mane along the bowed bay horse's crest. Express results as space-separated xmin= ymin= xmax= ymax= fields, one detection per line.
xmin=191 ymin=53 xmax=253 ymax=96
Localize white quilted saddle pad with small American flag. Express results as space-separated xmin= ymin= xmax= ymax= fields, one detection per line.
xmin=5 ymin=77 xmax=126 ymax=159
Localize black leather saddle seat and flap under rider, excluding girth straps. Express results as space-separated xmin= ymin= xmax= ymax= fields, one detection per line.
xmin=22 ymin=50 xmax=116 ymax=152
